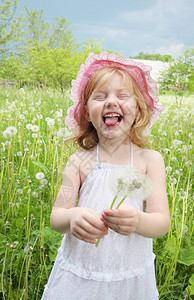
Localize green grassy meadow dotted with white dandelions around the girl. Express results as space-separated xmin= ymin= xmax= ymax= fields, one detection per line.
xmin=0 ymin=89 xmax=194 ymax=300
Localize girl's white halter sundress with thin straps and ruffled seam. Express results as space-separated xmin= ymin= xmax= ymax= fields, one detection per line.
xmin=42 ymin=144 xmax=158 ymax=300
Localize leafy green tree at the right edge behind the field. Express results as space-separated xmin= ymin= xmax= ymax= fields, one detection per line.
xmin=159 ymin=48 xmax=194 ymax=97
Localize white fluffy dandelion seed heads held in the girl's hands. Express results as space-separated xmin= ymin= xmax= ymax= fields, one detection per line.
xmin=95 ymin=168 xmax=152 ymax=247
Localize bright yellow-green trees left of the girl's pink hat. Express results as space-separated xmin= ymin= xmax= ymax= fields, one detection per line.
xmin=0 ymin=8 xmax=101 ymax=92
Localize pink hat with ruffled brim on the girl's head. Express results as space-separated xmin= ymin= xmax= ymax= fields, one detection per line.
xmin=65 ymin=51 xmax=164 ymax=135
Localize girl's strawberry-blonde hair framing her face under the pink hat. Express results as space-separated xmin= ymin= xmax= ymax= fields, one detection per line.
xmin=68 ymin=65 xmax=152 ymax=150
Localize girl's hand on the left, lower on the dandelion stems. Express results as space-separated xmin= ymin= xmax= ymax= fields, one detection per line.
xmin=70 ymin=207 xmax=108 ymax=244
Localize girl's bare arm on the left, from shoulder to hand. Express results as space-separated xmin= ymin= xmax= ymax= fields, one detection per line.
xmin=50 ymin=154 xmax=107 ymax=243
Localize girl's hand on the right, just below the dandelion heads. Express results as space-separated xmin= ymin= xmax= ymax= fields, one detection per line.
xmin=102 ymin=205 xmax=140 ymax=235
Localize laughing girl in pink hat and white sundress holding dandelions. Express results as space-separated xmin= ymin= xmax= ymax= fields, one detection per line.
xmin=42 ymin=52 xmax=170 ymax=300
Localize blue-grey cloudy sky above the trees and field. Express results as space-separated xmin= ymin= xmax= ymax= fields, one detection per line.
xmin=17 ymin=0 xmax=194 ymax=58
